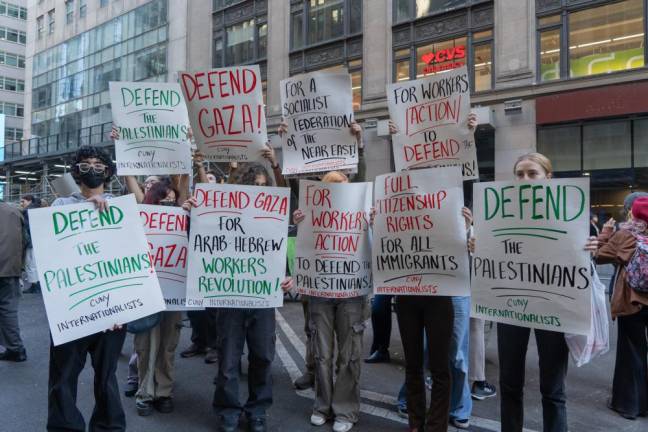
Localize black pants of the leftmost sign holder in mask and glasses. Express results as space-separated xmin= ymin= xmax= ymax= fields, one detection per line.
xmin=47 ymin=330 xmax=126 ymax=432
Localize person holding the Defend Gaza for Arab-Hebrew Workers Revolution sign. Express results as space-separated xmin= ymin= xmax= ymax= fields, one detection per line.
xmin=184 ymin=164 xmax=292 ymax=432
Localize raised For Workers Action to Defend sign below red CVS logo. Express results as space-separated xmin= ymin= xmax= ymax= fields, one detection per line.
xmin=387 ymin=66 xmax=479 ymax=180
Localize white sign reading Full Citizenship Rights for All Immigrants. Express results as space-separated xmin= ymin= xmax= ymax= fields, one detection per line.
xmin=373 ymin=167 xmax=470 ymax=296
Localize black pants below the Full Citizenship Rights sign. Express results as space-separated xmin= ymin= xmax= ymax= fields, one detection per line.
xmin=396 ymin=296 xmax=454 ymax=432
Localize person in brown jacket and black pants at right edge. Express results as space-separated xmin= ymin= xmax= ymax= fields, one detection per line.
xmin=595 ymin=194 xmax=648 ymax=420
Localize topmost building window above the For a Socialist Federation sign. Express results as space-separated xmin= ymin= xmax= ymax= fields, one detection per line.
xmin=290 ymin=0 xmax=362 ymax=49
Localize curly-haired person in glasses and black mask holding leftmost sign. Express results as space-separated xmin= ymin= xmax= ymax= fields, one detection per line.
xmin=47 ymin=146 xmax=126 ymax=432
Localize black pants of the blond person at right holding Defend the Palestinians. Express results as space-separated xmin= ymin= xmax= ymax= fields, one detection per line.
xmin=497 ymin=324 xmax=569 ymax=432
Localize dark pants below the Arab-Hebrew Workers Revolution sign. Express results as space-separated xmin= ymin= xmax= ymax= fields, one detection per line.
xmin=214 ymin=308 xmax=276 ymax=420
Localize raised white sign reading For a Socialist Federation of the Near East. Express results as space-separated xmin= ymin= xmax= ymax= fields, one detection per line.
xmin=281 ymin=72 xmax=358 ymax=176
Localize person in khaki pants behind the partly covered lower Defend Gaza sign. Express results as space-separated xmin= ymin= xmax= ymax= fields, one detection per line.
xmin=134 ymin=182 xmax=182 ymax=416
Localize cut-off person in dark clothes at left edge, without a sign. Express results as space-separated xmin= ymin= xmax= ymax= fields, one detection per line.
xmin=0 ymin=200 xmax=27 ymax=362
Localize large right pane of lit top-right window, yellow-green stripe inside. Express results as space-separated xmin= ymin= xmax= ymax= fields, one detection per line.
xmin=569 ymin=0 xmax=645 ymax=77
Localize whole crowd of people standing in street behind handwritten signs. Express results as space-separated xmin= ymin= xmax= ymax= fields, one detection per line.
xmin=0 ymin=117 xmax=648 ymax=432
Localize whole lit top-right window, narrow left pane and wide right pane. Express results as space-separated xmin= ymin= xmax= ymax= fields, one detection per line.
xmin=538 ymin=0 xmax=646 ymax=81
